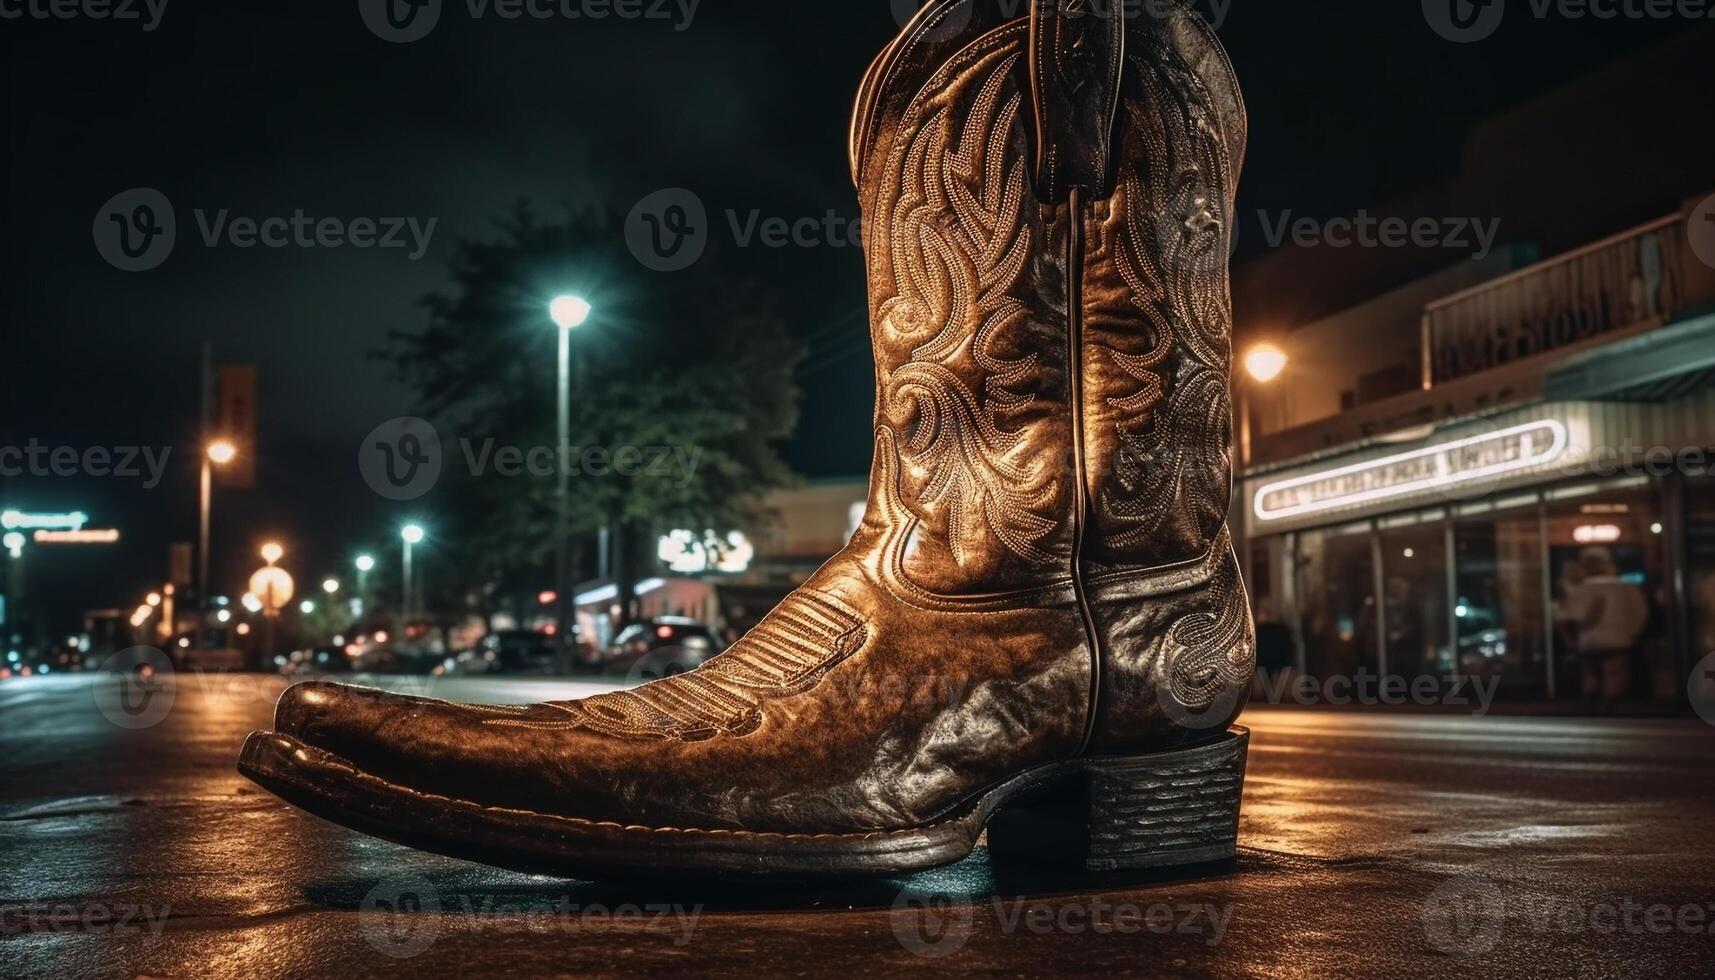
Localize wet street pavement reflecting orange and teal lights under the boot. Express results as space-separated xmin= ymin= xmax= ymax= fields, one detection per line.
xmin=0 ymin=675 xmax=1715 ymax=977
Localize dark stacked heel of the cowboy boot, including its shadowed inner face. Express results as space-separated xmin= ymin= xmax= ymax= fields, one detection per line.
xmin=988 ymin=726 xmax=1250 ymax=872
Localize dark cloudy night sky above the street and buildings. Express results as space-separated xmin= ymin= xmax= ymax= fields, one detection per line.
xmin=0 ymin=0 xmax=1686 ymax=628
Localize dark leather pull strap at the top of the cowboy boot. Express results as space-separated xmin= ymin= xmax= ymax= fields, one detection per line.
xmin=1031 ymin=0 xmax=1125 ymax=203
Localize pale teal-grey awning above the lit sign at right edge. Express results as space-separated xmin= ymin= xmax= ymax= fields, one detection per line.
xmin=1544 ymin=309 xmax=1715 ymax=403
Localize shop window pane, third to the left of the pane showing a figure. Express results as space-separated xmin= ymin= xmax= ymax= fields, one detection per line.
xmin=1298 ymin=525 xmax=1377 ymax=676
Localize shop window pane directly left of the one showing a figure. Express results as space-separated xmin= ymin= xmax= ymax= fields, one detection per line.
xmin=1453 ymin=501 xmax=1549 ymax=697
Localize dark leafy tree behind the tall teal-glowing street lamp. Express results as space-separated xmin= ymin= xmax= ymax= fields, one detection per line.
xmin=377 ymin=204 xmax=801 ymax=616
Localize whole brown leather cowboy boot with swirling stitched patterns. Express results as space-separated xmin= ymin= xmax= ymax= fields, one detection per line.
xmin=238 ymin=0 xmax=1254 ymax=877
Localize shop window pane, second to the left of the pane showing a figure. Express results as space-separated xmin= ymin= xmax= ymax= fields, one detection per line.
xmin=1381 ymin=520 xmax=1454 ymax=678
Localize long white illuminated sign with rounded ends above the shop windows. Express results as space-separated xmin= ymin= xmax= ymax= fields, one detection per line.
xmin=1254 ymin=420 xmax=1568 ymax=520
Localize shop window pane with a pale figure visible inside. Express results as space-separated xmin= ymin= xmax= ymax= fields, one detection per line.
xmin=1549 ymin=481 xmax=1679 ymax=702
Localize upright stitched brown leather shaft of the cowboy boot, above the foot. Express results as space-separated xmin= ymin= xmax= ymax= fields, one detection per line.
xmin=852 ymin=0 xmax=1245 ymax=597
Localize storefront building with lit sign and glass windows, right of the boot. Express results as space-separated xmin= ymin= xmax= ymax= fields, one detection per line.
xmin=1235 ymin=199 xmax=1715 ymax=705
